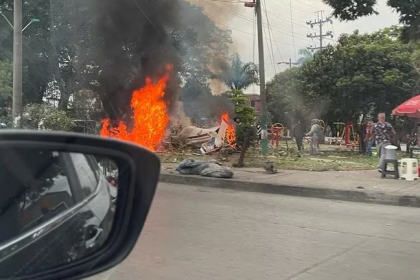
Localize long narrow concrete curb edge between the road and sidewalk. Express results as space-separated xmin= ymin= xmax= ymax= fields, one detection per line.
xmin=159 ymin=173 xmax=420 ymax=207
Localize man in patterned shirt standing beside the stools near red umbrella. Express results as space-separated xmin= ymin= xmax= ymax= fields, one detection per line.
xmin=373 ymin=113 xmax=395 ymax=172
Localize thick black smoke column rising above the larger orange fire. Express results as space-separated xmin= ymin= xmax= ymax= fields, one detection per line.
xmin=84 ymin=0 xmax=182 ymax=121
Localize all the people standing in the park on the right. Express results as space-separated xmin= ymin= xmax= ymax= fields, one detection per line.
xmin=293 ymin=113 xmax=396 ymax=172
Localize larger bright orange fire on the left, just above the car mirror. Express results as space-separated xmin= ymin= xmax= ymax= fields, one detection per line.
xmin=100 ymin=65 xmax=172 ymax=151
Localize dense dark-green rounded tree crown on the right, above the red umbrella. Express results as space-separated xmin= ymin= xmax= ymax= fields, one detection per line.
xmin=302 ymin=28 xmax=419 ymax=121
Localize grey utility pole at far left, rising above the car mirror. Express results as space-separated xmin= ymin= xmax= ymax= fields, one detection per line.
xmin=12 ymin=0 xmax=22 ymax=128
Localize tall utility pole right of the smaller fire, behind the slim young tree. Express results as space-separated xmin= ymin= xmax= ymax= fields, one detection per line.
xmin=255 ymin=0 xmax=268 ymax=155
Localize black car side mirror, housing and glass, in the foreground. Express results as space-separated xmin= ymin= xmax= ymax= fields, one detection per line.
xmin=0 ymin=130 xmax=160 ymax=280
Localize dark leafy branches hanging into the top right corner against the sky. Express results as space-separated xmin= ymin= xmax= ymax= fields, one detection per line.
xmin=323 ymin=0 xmax=420 ymax=40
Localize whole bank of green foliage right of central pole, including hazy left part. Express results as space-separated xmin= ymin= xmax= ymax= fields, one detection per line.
xmin=267 ymin=27 xmax=420 ymax=128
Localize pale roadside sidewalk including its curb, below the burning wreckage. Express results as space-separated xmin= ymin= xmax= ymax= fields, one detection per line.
xmin=160 ymin=164 xmax=420 ymax=207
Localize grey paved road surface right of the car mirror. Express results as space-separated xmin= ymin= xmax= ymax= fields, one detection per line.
xmin=90 ymin=184 xmax=420 ymax=280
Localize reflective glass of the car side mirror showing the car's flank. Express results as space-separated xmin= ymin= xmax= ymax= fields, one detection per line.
xmin=0 ymin=147 xmax=118 ymax=279
